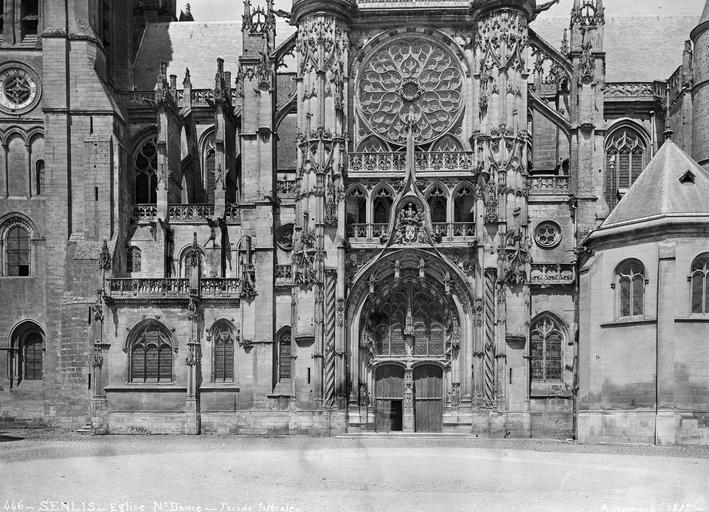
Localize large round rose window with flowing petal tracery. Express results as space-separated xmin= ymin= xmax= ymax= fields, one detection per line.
xmin=359 ymin=37 xmax=463 ymax=145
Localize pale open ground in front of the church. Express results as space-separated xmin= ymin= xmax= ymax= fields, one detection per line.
xmin=0 ymin=431 xmax=709 ymax=512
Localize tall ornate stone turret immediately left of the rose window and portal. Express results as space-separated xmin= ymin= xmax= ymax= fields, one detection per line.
xmin=292 ymin=0 xmax=352 ymax=408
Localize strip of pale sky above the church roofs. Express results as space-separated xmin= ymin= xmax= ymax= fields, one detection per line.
xmin=184 ymin=0 xmax=705 ymax=21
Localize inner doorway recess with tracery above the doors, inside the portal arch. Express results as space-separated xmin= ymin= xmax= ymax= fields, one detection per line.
xmin=366 ymin=276 xmax=457 ymax=432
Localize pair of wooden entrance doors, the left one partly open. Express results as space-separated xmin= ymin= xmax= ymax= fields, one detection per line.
xmin=375 ymin=365 xmax=443 ymax=432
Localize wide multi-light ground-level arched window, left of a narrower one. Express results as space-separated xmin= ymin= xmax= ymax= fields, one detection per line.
xmin=129 ymin=322 xmax=173 ymax=382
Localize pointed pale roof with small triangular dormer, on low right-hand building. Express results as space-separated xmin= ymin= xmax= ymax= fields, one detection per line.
xmin=600 ymin=140 xmax=709 ymax=230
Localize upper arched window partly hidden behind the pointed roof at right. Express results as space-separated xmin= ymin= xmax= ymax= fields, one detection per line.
xmin=606 ymin=128 xmax=647 ymax=209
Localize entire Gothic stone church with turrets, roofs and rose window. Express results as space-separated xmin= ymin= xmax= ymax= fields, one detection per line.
xmin=0 ymin=0 xmax=709 ymax=444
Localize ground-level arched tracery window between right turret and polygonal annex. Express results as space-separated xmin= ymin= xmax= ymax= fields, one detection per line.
xmin=530 ymin=315 xmax=564 ymax=382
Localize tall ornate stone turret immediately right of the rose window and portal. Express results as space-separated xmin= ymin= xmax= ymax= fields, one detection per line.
xmin=472 ymin=0 xmax=535 ymax=420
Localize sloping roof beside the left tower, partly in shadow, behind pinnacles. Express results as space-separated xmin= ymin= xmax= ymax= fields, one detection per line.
xmin=134 ymin=21 xmax=294 ymax=90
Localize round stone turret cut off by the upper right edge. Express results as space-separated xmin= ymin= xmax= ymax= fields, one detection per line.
xmin=690 ymin=0 xmax=709 ymax=169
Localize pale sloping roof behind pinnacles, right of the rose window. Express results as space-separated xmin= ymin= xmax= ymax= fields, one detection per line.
xmin=531 ymin=16 xmax=696 ymax=82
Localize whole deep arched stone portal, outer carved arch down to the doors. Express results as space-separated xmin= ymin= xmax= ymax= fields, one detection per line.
xmin=349 ymin=248 xmax=473 ymax=432
